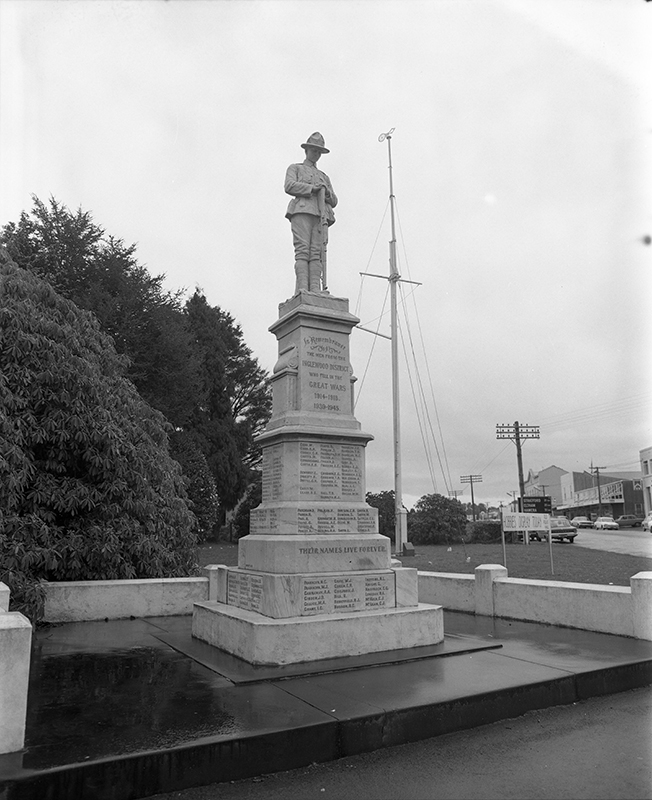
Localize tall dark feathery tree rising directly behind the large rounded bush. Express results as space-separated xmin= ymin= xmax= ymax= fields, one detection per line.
xmin=0 ymin=198 xmax=199 ymax=426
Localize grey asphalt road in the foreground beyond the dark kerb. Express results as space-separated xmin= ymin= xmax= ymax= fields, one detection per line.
xmin=153 ymin=687 xmax=652 ymax=800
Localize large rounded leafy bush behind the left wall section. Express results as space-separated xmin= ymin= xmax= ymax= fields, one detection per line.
xmin=0 ymin=253 xmax=197 ymax=618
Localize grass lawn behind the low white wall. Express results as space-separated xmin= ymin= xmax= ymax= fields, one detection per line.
xmin=197 ymin=542 xmax=652 ymax=586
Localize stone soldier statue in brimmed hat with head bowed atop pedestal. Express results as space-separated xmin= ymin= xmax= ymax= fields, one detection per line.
xmin=285 ymin=133 xmax=337 ymax=294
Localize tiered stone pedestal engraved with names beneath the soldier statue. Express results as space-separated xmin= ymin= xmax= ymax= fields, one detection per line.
xmin=193 ymin=292 xmax=444 ymax=664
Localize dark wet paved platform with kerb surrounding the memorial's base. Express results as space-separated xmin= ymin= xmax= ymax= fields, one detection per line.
xmin=0 ymin=612 xmax=652 ymax=800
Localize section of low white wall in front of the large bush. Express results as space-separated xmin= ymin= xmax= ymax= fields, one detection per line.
xmin=43 ymin=577 xmax=208 ymax=622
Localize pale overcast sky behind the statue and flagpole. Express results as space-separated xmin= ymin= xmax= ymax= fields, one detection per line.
xmin=0 ymin=0 xmax=652 ymax=505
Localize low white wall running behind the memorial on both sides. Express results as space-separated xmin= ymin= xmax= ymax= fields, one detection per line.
xmin=39 ymin=564 xmax=652 ymax=641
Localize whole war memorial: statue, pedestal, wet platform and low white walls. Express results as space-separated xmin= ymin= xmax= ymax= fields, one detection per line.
xmin=0 ymin=133 xmax=652 ymax=800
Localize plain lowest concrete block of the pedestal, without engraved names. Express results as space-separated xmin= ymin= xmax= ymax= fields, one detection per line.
xmin=192 ymin=602 xmax=444 ymax=664
